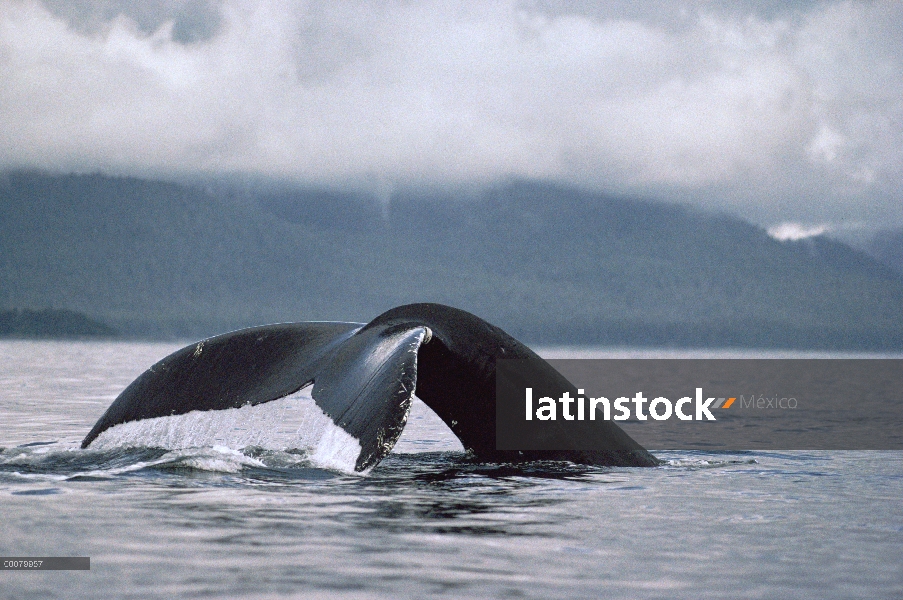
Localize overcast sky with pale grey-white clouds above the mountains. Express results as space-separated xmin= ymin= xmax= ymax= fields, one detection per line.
xmin=0 ymin=0 xmax=903 ymax=232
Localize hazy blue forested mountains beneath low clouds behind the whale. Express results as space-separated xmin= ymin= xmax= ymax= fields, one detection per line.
xmin=0 ymin=171 xmax=903 ymax=349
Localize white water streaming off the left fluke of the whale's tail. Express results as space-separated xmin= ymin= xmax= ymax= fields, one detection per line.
xmin=91 ymin=386 xmax=361 ymax=473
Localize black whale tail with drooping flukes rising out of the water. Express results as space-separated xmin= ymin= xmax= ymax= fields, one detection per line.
xmin=81 ymin=304 xmax=658 ymax=471
